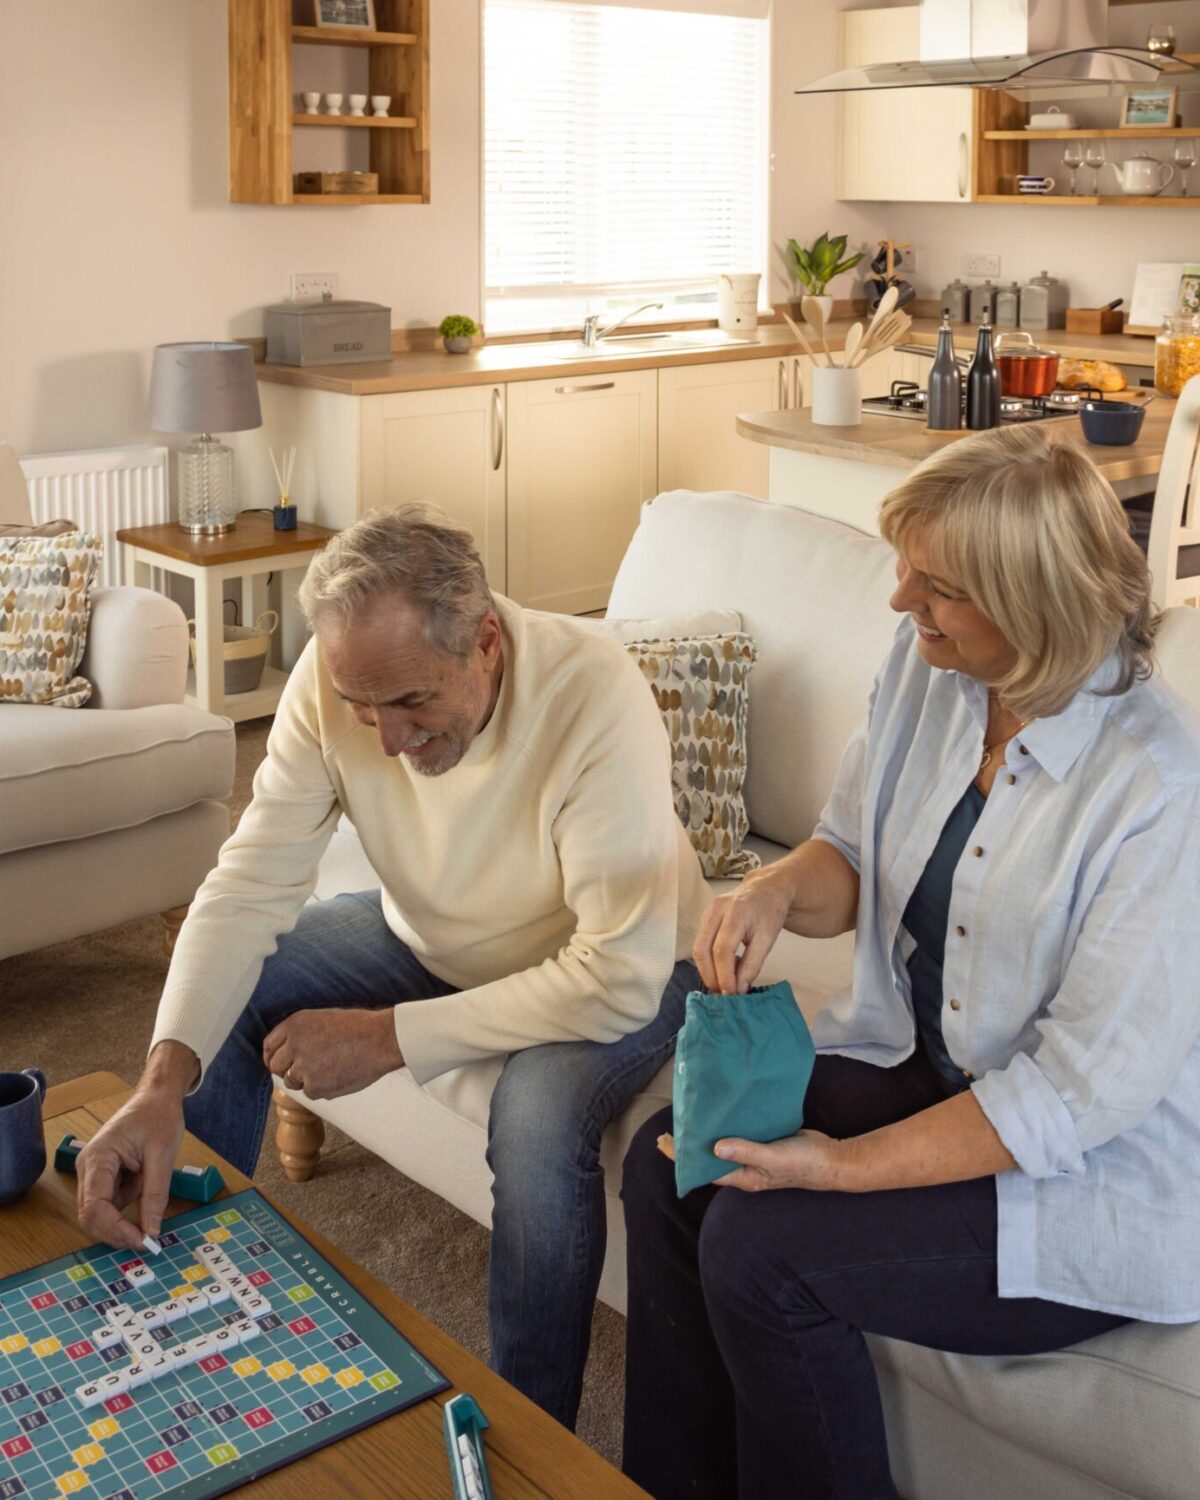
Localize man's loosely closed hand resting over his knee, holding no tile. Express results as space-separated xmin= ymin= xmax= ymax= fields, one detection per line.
xmin=263 ymin=1007 xmax=404 ymax=1100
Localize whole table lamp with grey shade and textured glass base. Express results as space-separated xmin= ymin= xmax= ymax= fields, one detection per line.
xmin=150 ymin=344 xmax=263 ymax=536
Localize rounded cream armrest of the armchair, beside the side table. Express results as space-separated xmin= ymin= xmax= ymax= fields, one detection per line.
xmin=80 ymin=588 xmax=188 ymax=708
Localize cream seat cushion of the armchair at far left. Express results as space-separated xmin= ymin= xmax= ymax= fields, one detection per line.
xmin=0 ymin=704 xmax=234 ymax=854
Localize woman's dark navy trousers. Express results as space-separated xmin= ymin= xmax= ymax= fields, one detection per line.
xmin=621 ymin=1052 xmax=1128 ymax=1500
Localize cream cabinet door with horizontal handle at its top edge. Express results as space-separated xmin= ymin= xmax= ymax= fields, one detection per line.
xmin=506 ymin=368 xmax=659 ymax=615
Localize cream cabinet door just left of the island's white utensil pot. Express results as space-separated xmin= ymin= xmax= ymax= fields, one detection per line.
xmin=659 ymin=356 xmax=809 ymax=500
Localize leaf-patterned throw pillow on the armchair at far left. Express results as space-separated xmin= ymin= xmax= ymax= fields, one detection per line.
xmin=0 ymin=531 xmax=104 ymax=708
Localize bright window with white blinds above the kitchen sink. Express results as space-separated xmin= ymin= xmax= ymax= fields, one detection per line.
xmin=483 ymin=0 xmax=770 ymax=333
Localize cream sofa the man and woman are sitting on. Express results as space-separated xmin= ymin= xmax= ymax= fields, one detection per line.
xmin=297 ymin=491 xmax=1200 ymax=1500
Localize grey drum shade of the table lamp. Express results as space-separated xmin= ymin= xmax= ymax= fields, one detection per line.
xmin=150 ymin=344 xmax=263 ymax=432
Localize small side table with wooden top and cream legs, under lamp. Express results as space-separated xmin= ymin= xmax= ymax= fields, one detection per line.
xmin=117 ymin=510 xmax=338 ymax=723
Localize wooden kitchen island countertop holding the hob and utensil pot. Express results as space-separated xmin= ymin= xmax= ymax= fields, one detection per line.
xmin=738 ymin=396 xmax=1175 ymax=485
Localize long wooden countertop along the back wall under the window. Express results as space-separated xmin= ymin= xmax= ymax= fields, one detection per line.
xmin=255 ymin=318 xmax=1154 ymax=396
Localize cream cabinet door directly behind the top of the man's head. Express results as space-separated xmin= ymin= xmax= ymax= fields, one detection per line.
xmin=359 ymin=386 xmax=509 ymax=594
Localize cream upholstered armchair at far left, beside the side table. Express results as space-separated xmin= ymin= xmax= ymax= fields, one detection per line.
xmin=0 ymin=447 xmax=236 ymax=959
